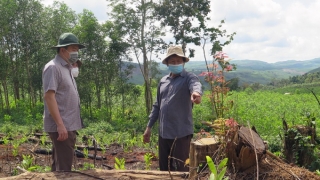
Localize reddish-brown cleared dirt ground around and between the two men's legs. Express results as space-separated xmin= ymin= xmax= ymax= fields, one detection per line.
xmin=0 ymin=140 xmax=158 ymax=178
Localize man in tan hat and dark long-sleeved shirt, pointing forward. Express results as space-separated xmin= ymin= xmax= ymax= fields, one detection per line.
xmin=143 ymin=46 xmax=202 ymax=171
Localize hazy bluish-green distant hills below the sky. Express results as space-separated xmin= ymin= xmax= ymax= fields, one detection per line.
xmin=130 ymin=58 xmax=320 ymax=85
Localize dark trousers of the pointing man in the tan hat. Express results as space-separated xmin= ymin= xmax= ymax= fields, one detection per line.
xmin=159 ymin=134 xmax=193 ymax=172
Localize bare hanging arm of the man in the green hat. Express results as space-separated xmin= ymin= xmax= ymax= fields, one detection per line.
xmin=44 ymin=90 xmax=68 ymax=141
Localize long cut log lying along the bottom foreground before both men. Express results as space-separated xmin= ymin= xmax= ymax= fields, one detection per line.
xmin=0 ymin=169 xmax=186 ymax=180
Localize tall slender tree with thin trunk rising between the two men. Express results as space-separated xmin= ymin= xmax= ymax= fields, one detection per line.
xmin=110 ymin=0 xmax=163 ymax=114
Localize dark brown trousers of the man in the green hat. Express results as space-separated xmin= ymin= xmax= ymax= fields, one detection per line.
xmin=48 ymin=131 xmax=77 ymax=171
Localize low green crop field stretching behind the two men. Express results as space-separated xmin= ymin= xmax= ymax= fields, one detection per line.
xmin=0 ymin=88 xmax=320 ymax=173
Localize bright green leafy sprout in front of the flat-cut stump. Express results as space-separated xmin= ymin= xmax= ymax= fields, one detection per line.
xmin=206 ymin=156 xmax=228 ymax=180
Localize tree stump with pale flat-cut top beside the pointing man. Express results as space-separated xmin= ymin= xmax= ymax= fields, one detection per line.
xmin=189 ymin=138 xmax=219 ymax=179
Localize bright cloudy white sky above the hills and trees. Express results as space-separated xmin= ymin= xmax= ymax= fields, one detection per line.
xmin=42 ymin=0 xmax=320 ymax=63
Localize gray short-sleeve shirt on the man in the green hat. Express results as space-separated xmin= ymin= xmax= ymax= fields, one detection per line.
xmin=42 ymin=55 xmax=83 ymax=132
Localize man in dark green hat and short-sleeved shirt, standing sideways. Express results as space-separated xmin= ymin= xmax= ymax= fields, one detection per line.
xmin=42 ymin=33 xmax=84 ymax=171
